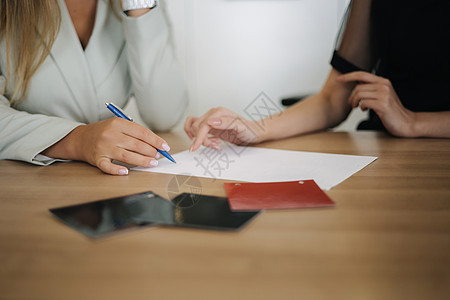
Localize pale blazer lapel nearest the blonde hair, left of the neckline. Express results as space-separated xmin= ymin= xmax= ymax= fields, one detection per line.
xmin=50 ymin=0 xmax=99 ymax=123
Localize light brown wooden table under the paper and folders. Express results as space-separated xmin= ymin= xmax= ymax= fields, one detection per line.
xmin=0 ymin=132 xmax=450 ymax=299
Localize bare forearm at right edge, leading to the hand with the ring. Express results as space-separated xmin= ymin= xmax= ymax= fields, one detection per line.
xmin=412 ymin=111 xmax=450 ymax=138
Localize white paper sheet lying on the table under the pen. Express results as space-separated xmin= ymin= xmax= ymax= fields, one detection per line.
xmin=133 ymin=144 xmax=377 ymax=190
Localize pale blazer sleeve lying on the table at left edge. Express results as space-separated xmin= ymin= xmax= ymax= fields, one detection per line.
xmin=0 ymin=76 xmax=81 ymax=165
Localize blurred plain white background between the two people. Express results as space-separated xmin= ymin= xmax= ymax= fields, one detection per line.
xmin=126 ymin=0 xmax=365 ymax=130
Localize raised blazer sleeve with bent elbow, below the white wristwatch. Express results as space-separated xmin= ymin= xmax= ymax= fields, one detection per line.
xmin=123 ymin=1 xmax=188 ymax=131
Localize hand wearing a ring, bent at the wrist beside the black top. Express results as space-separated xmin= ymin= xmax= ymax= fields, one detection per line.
xmin=336 ymin=72 xmax=415 ymax=137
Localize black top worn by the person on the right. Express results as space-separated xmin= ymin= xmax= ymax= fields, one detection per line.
xmin=331 ymin=0 xmax=450 ymax=129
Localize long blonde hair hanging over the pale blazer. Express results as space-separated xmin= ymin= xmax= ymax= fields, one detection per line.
xmin=0 ymin=0 xmax=61 ymax=102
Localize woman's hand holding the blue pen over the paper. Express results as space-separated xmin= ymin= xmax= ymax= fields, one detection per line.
xmin=43 ymin=118 xmax=170 ymax=175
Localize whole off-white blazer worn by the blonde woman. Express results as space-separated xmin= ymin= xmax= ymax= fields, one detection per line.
xmin=0 ymin=0 xmax=187 ymax=165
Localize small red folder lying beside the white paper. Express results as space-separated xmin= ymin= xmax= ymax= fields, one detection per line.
xmin=225 ymin=180 xmax=335 ymax=211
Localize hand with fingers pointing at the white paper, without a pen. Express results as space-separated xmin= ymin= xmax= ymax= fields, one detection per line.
xmin=184 ymin=107 xmax=262 ymax=151
